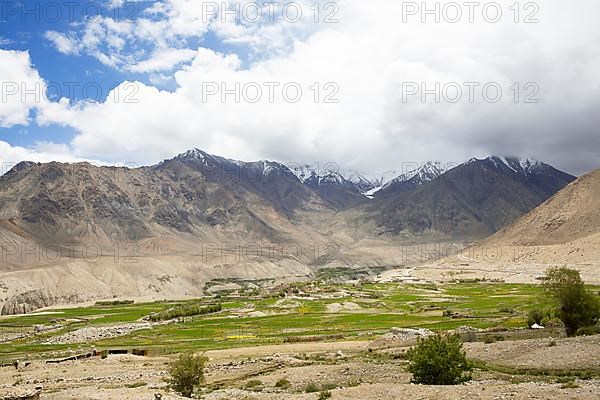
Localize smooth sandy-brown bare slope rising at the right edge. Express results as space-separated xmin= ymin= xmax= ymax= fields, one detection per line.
xmin=414 ymin=170 xmax=600 ymax=283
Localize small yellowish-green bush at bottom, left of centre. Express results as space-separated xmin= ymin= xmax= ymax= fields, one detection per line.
xmin=167 ymin=354 xmax=206 ymax=397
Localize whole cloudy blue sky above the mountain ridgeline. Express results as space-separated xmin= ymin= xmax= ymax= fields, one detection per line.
xmin=0 ymin=0 xmax=600 ymax=175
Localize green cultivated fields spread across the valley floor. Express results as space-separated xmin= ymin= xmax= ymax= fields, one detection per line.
xmin=0 ymin=283 xmax=580 ymax=362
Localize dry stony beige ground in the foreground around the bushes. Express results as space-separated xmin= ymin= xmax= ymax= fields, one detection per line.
xmin=0 ymin=336 xmax=600 ymax=400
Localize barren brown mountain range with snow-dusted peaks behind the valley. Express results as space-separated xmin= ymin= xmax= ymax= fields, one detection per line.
xmin=0 ymin=149 xmax=575 ymax=308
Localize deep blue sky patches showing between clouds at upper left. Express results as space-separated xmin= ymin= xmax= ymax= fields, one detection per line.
xmin=0 ymin=0 xmax=232 ymax=146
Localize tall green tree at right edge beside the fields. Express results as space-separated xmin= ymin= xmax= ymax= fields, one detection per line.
xmin=543 ymin=267 xmax=600 ymax=336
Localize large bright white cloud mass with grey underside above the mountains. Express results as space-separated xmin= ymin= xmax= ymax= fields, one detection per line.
xmin=23 ymin=0 xmax=600 ymax=173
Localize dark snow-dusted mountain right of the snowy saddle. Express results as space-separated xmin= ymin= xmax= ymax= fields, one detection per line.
xmin=358 ymin=156 xmax=575 ymax=240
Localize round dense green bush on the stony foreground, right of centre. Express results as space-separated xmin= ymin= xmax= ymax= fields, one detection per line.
xmin=407 ymin=334 xmax=472 ymax=385
